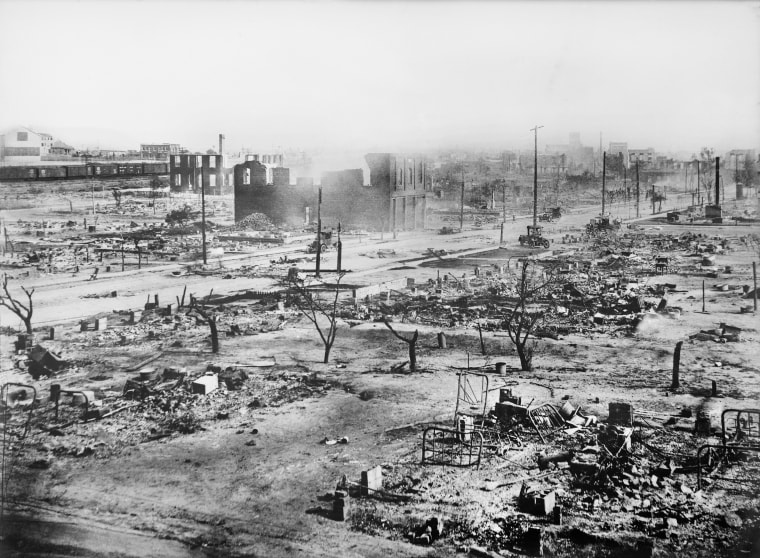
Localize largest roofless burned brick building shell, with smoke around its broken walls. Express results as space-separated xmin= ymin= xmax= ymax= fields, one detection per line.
xmin=234 ymin=153 xmax=427 ymax=230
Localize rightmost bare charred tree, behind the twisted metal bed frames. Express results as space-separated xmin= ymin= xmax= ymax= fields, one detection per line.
xmin=504 ymin=262 xmax=556 ymax=371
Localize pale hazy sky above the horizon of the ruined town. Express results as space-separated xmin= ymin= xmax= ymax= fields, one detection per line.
xmin=0 ymin=0 xmax=760 ymax=155
